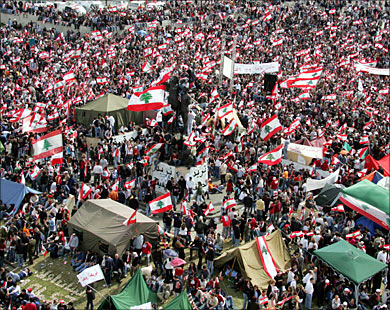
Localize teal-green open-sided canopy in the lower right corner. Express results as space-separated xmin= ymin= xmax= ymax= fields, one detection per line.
xmin=314 ymin=240 xmax=387 ymax=285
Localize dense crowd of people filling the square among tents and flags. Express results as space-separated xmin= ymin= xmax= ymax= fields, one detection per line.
xmin=0 ymin=0 xmax=390 ymax=310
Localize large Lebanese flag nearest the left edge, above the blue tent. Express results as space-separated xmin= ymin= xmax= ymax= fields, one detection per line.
xmin=32 ymin=129 xmax=62 ymax=160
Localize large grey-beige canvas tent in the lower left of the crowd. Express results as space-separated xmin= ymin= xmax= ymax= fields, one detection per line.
xmin=68 ymin=199 xmax=158 ymax=256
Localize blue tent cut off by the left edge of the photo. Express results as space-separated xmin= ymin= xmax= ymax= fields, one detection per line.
xmin=0 ymin=179 xmax=42 ymax=208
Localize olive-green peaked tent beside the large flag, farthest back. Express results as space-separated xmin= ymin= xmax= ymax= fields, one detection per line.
xmin=75 ymin=94 xmax=143 ymax=129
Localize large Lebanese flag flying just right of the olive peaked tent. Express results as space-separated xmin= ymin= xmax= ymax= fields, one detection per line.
xmin=127 ymin=85 xmax=165 ymax=112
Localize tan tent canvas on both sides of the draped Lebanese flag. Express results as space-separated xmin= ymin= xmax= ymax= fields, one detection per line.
xmin=215 ymin=230 xmax=291 ymax=288
